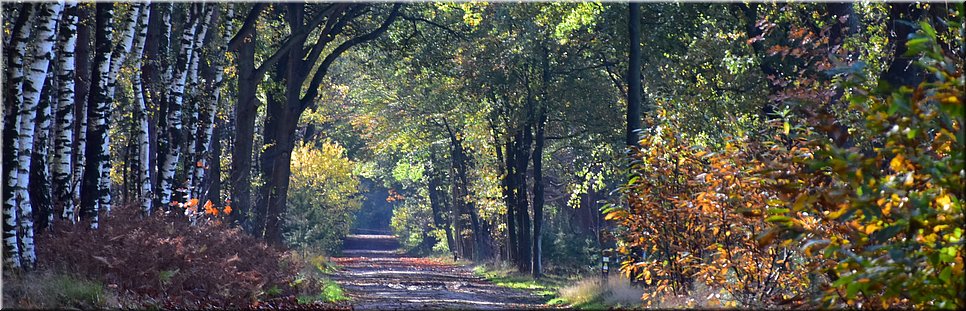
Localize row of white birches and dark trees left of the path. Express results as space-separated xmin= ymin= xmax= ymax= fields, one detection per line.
xmin=3 ymin=1 xmax=400 ymax=267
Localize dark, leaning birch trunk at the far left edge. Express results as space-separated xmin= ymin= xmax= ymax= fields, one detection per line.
xmin=3 ymin=3 xmax=39 ymax=268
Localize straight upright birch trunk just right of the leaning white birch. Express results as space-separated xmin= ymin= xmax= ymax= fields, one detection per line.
xmin=53 ymin=1 xmax=78 ymax=220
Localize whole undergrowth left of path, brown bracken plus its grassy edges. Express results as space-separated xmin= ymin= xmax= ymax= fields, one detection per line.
xmin=4 ymin=207 xmax=344 ymax=309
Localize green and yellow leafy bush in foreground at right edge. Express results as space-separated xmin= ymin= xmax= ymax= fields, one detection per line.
xmin=762 ymin=15 xmax=966 ymax=309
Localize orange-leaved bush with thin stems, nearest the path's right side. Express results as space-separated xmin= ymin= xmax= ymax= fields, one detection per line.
xmin=605 ymin=113 xmax=809 ymax=307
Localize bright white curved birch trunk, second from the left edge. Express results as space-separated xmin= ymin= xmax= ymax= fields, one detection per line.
xmin=15 ymin=0 xmax=64 ymax=267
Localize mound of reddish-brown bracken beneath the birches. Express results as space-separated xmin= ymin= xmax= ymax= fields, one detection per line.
xmin=37 ymin=207 xmax=299 ymax=309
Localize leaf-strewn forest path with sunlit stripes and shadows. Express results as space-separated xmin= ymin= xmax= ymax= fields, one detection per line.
xmin=331 ymin=235 xmax=548 ymax=310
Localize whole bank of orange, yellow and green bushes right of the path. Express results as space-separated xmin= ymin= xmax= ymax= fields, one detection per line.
xmin=605 ymin=6 xmax=966 ymax=309
